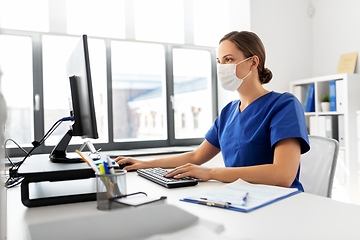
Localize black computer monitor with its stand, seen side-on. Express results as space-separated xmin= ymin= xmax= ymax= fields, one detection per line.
xmin=50 ymin=35 xmax=99 ymax=163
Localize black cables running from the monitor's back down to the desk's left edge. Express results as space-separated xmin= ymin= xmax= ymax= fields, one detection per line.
xmin=4 ymin=117 xmax=74 ymax=188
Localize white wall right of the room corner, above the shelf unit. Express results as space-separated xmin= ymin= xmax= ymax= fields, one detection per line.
xmin=312 ymin=0 xmax=360 ymax=76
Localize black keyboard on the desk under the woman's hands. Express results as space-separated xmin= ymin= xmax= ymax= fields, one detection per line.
xmin=137 ymin=168 xmax=197 ymax=188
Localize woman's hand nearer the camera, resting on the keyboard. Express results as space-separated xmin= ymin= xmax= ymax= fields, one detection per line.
xmin=164 ymin=163 xmax=211 ymax=181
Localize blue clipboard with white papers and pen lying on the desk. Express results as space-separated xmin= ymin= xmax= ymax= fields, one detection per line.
xmin=180 ymin=179 xmax=300 ymax=212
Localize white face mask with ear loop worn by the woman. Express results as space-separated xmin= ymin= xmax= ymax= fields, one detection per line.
xmin=217 ymin=57 xmax=252 ymax=91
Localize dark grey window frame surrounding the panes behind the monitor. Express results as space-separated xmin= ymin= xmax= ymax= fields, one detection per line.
xmin=1 ymin=29 xmax=218 ymax=157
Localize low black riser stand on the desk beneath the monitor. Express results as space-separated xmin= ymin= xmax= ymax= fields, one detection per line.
xmin=18 ymin=154 xmax=97 ymax=207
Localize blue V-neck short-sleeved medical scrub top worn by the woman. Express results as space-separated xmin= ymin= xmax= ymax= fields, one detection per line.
xmin=205 ymin=92 xmax=310 ymax=191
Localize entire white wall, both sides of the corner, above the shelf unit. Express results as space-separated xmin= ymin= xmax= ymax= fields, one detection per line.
xmin=251 ymin=0 xmax=360 ymax=89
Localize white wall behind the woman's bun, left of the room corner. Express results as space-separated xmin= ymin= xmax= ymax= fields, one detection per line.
xmin=251 ymin=0 xmax=314 ymax=92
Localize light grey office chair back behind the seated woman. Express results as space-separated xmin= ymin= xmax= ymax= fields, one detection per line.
xmin=300 ymin=136 xmax=339 ymax=197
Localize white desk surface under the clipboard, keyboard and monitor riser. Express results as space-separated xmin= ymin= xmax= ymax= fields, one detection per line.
xmin=7 ymin=154 xmax=360 ymax=240
